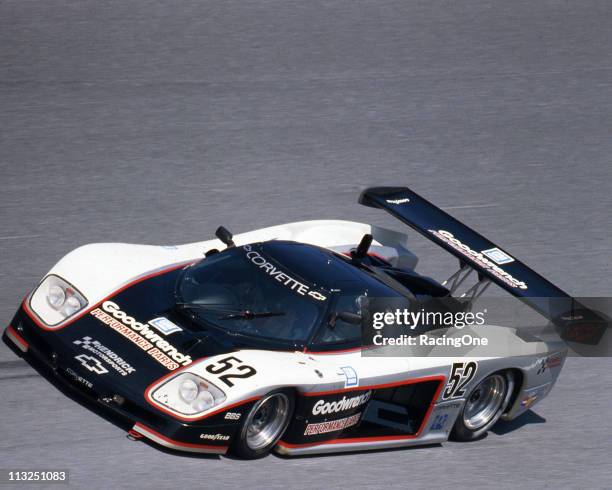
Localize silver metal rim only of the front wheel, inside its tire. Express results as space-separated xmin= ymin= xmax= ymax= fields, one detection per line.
xmin=245 ymin=393 xmax=289 ymax=451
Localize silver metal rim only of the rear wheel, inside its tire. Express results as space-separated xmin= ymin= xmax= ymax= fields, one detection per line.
xmin=463 ymin=374 xmax=507 ymax=430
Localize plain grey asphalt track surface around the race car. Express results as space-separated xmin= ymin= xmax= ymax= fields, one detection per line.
xmin=0 ymin=0 xmax=612 ymax=488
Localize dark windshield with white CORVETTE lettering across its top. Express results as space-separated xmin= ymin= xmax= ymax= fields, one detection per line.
xmin=177 ymin=245 xmax=329 ymax=343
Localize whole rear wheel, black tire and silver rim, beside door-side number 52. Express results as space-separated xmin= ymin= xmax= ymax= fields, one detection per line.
xmin=450 ymin=371 xmax=514 ymax=441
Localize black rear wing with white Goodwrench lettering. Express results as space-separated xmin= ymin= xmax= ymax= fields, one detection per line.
xmin=359 ymin=187 xmax=608 ymax=343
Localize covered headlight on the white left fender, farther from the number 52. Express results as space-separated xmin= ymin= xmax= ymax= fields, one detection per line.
xmin=30 ymin=274 xmax=87 ymax=327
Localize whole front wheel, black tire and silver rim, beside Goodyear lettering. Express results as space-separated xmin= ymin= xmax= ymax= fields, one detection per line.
xmin=230 ymin=390 xmax=295 ymax=459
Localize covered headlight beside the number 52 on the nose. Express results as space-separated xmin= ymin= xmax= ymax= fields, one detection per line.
xmin=150 ymin=372 xmax=225 ymax=417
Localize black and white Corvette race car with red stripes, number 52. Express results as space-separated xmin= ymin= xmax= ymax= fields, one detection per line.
xmin=3 ymin=187 xmax=580 ymax=458
